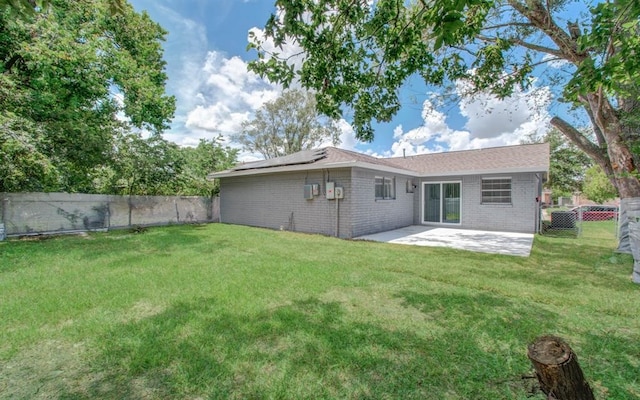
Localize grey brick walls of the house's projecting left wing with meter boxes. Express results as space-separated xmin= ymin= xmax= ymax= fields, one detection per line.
xmin=220 ymin=169 xmax=418 ymax=238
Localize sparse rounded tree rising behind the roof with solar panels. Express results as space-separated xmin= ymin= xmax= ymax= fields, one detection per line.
xmin=233 ymin=90 xmax=340 ymax=158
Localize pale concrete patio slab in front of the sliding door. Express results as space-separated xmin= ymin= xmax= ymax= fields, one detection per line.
xmin=355 ymin=225 xmax=533 ymax=257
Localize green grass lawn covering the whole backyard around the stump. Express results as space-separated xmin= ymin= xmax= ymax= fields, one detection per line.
xmin=0 ymin=222 xmax=640 ymax=399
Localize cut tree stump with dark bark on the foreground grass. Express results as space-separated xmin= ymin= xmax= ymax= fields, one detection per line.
xmin=527 ymin=336 xmax=595 ymax=400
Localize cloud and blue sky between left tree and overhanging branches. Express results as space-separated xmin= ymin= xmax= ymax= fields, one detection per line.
xmin=125 ymin=5 xmax=280 ymax=146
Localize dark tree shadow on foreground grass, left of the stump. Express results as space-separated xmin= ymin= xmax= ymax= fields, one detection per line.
xmin=57 ymin=292 xmax=555 ymax=399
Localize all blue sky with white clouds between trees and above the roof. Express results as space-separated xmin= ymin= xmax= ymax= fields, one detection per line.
xmin=129 ymin=0 xmax=551 ymax=160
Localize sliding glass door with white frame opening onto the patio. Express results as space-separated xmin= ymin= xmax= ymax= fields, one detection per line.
xmin=422 ymin=182 xmax=462 ymax=224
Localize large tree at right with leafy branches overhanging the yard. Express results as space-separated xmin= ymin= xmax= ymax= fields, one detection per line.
xmin=251 ymin=0 xmax=640 ymax=247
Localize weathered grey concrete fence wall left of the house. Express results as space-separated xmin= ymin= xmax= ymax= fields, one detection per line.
xmin=0 ymin=193 xmax=220 ymax=236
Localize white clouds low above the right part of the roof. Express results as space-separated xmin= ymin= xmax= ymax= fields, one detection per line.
xmin=385 ymin=85 xmax=551 ymax=157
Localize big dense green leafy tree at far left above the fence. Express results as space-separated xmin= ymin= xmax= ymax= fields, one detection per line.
xmin=0 ymin=0 xmax=175 ymax=191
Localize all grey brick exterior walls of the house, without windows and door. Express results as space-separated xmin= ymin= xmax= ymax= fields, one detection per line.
xmin=220 ymin=168 xmax=539 ymax=238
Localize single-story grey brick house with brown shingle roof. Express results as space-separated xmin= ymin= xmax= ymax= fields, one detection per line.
xmin=209 ymin=143 xmax=549 ymax=238
